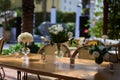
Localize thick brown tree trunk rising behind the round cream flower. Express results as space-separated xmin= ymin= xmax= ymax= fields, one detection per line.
xmin=21 ymin=0 xmax=34 ymax=34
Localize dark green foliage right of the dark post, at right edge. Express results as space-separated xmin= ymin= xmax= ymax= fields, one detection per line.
xmin=107 ymin=0 xmax=120 ymax=39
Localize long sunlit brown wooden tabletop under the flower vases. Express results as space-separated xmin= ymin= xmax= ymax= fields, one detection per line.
xmin=0 ymin=54 xmax=108 ymax=80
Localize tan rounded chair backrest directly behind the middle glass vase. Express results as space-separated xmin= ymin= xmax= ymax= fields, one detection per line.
xmin=38 ymin=44 xmax=70 ymax=57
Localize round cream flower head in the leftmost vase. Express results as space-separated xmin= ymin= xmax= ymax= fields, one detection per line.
xmin=18 ymin=32 xmax=33 ymax=43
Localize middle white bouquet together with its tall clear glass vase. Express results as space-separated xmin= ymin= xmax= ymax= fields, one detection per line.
xmin=48 ymin=24 xmax=73 ymax=58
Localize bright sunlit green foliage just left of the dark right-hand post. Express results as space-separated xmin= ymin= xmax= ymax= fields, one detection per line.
xmin=88 ymin=0 xmax=103 ymax=37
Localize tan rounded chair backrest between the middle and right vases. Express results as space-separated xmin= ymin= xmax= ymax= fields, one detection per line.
xmin=72 ymin=46 xmax=93 ymax=60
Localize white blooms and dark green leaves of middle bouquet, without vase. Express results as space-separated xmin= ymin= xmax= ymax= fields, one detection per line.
xmin=48 ymin=24 xmax=69 ymax=43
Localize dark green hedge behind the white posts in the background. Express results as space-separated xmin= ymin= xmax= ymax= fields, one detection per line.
xmin=35 ymin=11 xmax=75 ymax=27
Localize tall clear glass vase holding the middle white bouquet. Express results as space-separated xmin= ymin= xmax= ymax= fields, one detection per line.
xmin=55 ymin=43 xmax=63 ymax=63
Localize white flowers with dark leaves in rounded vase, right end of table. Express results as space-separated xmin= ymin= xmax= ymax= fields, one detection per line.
xmin=89 ymin=44 xmax=110 ymax=64
